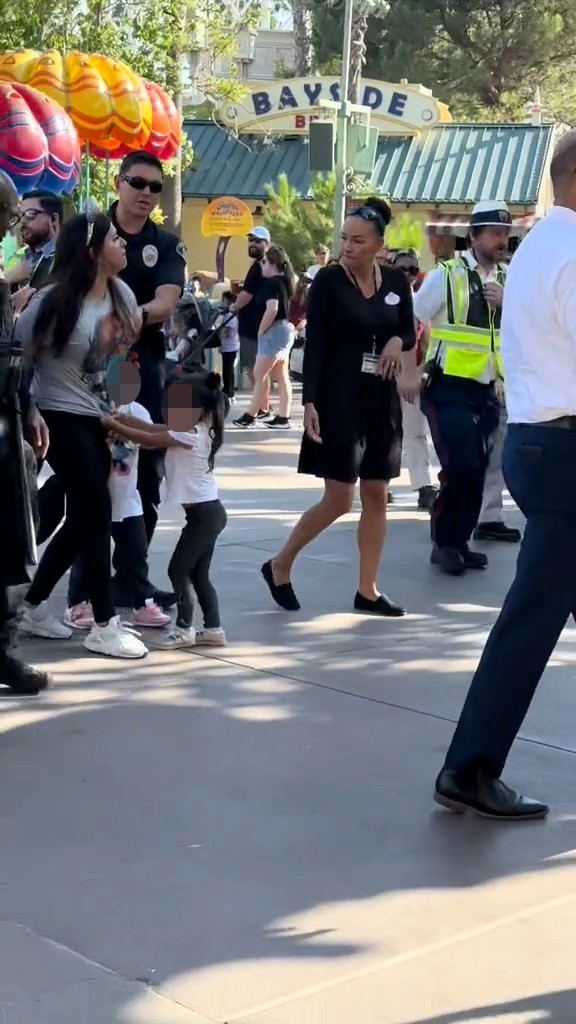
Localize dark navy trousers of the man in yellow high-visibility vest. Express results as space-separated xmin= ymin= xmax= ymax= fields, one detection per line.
xmin=421 ymin=376 xmax=499 ymax=549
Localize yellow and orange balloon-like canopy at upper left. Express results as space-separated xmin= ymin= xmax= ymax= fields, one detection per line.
xmin=0 ymin=50 xmax=181 ymax=176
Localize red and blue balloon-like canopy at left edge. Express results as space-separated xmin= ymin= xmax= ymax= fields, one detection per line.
xmin=0 ymin=82 xmax=81 ymax=194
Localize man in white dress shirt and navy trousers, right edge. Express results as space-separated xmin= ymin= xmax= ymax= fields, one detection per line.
xmin=436 ymin=132 xmax=576 ymax=820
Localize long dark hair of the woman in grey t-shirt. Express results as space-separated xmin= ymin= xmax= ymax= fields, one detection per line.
xmin=33 ymin=213 xmax=135 ymax=355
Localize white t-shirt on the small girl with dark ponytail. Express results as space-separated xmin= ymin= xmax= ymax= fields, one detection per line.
xmin=161 ymin=423 xmax=218 ymax=505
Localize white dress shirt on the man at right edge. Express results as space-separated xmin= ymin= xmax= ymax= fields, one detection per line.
xmin=500 ymin=206 xmax=576 ymax=423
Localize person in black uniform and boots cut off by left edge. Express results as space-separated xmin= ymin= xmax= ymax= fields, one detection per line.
xmin=0 ymin=171 xmax=49 ymax=694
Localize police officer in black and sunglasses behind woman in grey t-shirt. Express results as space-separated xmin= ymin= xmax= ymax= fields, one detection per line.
xmin=110 ymin=153 xmax=186 ymax=606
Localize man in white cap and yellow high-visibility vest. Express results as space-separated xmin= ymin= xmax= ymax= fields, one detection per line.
xmin=414 ymin=202 xmax=511 ymax=575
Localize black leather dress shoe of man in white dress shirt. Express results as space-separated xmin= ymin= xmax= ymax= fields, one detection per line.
xmin=434 ymin=769 xmax=549 ymax=821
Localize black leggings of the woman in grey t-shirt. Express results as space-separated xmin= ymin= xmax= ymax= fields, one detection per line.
xmin=27 ymin=412 xmax=115 ymax=623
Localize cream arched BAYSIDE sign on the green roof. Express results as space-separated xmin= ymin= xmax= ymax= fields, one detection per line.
xmin=220 ymin=78 xmax=444 ymax=135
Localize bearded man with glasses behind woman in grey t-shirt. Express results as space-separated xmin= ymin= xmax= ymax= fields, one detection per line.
xmin=6 ymin=188 xmax=64 ymax=313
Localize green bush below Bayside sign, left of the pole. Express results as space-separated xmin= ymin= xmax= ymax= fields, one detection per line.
xmin=264 ymin=174 xmax=335 ymax=273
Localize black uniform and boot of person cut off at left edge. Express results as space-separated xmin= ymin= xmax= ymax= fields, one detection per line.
xmin=0 ymin=286 xmax=48 ymax=693
